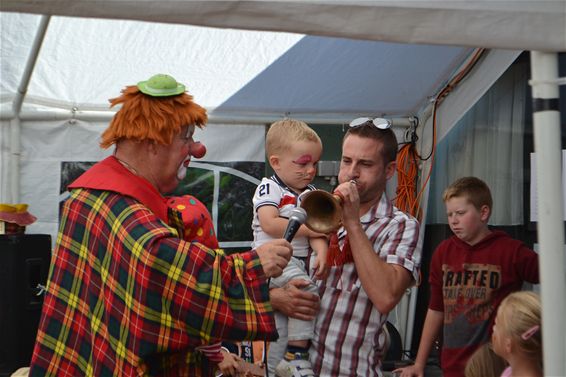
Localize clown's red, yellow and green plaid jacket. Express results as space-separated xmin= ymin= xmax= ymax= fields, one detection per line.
xmin=30 ymin=157 xmax=277 ymax=377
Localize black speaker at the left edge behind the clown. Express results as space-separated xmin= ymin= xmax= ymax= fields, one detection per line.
xmin=0 ymin=234 xmax=51 ymax=376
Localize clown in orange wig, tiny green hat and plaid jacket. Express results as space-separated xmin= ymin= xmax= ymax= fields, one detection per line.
xmin=30 ymin=75 xmax=291 ymax=376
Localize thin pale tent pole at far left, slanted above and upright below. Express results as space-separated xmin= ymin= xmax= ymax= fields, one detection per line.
xmin=10 ymin=15 xmax=51 ymax=203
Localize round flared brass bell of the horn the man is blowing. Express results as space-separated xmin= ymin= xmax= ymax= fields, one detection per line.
xmin=301 ymin=190 xmax=342 ymax=233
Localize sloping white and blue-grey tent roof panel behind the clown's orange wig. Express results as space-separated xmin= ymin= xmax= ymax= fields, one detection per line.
xmin=0 ymin=13 xmax=470 ymax=119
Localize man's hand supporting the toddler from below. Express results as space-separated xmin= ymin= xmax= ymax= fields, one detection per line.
xmin=269 ymin=279 xmax=320 ymax=321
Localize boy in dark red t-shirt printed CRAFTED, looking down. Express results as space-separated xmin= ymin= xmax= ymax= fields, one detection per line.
xmin=394 ymin=177 xmax=539 ymax=377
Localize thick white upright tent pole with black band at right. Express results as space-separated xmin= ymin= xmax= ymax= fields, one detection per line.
xmin=530 ymin=51 xmax=566 ymax=376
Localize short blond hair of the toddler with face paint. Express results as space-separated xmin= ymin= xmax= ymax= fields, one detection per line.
xmin=265 ymin=119 xmax=322 ymax=158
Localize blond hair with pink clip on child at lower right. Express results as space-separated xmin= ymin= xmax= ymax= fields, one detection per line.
xmin=497 ymin=291 xmax=542 ymax=363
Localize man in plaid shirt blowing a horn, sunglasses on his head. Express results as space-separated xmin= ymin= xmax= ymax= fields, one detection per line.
xmin=270 ymin=118 xmax=421 ymax=376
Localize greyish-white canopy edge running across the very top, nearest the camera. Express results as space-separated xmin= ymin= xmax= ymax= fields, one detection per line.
xmin=2 ymin=0 xmax=566 ymax=51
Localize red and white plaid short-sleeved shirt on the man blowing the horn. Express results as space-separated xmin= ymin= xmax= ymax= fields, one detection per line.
xmin=310 ymin=195 xmax=421 ymax=376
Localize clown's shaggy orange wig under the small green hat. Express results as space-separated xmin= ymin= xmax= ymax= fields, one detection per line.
xmin=100 ymin=85 xmax=208 ymax=148
